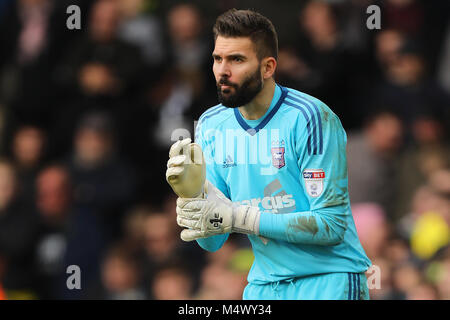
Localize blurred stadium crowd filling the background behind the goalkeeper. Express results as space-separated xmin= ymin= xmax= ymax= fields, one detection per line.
xmin=0 ymin=0 xmax=450 ymax=299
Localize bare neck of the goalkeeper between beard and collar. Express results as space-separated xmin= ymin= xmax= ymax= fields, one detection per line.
xmin=239 ymin=78 xmax=275 ymax=120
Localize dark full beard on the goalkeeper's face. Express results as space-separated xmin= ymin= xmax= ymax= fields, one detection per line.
xmin=217 ymin=68 xmax=263 ymax=108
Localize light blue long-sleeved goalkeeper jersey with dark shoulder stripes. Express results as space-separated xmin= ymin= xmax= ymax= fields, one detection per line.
xmin=195 ymin=84 xmax=371 ymax=284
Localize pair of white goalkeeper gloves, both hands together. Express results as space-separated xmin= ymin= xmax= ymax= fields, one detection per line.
xmin=166 ymin=138 xmax=260 ymax=241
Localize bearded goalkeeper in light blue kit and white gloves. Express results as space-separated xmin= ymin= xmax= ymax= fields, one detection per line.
xmin=166 ymin=9 xmax=370 ymax=300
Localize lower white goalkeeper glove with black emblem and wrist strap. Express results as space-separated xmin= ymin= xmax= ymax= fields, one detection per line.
xmin=176 ymin=180 xmax=260 ymax=241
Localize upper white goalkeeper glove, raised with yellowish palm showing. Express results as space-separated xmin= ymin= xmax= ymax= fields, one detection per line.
xmin=166 ymin=138 xmax=206 ymax=198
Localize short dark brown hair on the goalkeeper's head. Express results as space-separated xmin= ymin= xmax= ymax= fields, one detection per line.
xmin=213 ymin=9 xmax=278 ymax=60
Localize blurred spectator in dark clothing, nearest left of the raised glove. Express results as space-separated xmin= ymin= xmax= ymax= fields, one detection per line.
xmin=68 ymin=113 xmax=135 ymax=238
